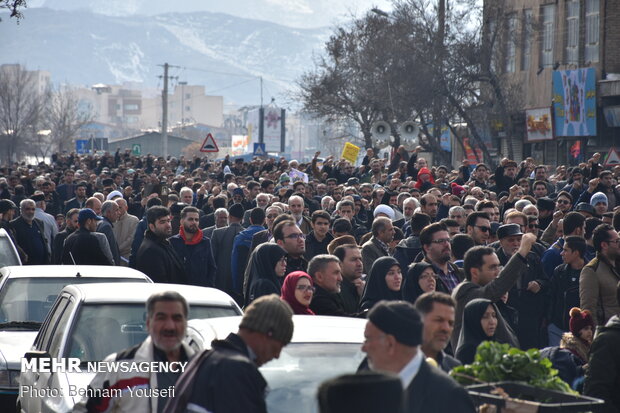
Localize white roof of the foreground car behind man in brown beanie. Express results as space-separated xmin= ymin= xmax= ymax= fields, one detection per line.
xmin=188 ymin=315 xmax=366 ymax=343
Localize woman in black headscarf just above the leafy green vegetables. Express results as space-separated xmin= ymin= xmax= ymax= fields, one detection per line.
xmin=455 ymin=298 xmax=499 ymax=364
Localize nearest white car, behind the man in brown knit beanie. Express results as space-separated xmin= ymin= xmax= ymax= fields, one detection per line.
xmin=187 ymin=315 xmax=366 ymax=413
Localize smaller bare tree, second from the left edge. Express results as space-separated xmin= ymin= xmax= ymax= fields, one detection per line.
xmin=45 ymin=86 xmax=93 ymax=152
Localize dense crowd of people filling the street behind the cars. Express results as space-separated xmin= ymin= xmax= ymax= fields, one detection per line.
xmin=0 ymin=147 xmax=620 ymax=411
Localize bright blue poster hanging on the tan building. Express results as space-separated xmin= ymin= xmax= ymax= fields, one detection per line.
xmin=553 ymin=68 xmax=596 ymax=136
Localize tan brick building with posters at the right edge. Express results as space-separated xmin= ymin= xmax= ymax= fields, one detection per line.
xmin=484 ymin=0 xmax=620 ymax=165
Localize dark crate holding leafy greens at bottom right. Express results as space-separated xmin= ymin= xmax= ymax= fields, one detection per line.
xmin=466 ymin=381 xmax=605 ymax=413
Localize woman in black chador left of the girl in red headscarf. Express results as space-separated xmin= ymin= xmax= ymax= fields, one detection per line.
xmin=245 ymin=243 xmax=286 ymax=306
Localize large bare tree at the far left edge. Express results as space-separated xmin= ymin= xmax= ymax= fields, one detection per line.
xmin=0 ymin=65 xmax=44 ymax=163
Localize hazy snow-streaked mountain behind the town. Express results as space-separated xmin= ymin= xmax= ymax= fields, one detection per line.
xmin=0 ymin=7 xmax=331 ymax=104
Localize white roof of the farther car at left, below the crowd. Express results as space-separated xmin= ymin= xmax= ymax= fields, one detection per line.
xmin=0 ymin=265 xmax=150 ymax=281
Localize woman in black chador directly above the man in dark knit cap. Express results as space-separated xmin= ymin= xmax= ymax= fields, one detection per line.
xmin=360 ymin=257 xmax=403 ymax=311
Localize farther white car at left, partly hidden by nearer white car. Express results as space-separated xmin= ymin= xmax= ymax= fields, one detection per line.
xmin=0 ymin=265 xmax=152 ymax=403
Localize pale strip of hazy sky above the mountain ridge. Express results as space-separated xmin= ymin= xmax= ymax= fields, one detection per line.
xmin=25 ymin=0 xmax=391 ymax=28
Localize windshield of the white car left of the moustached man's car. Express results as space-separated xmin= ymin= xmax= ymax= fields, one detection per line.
xmin=0 ymin=277 xmax=146 ymax=330
